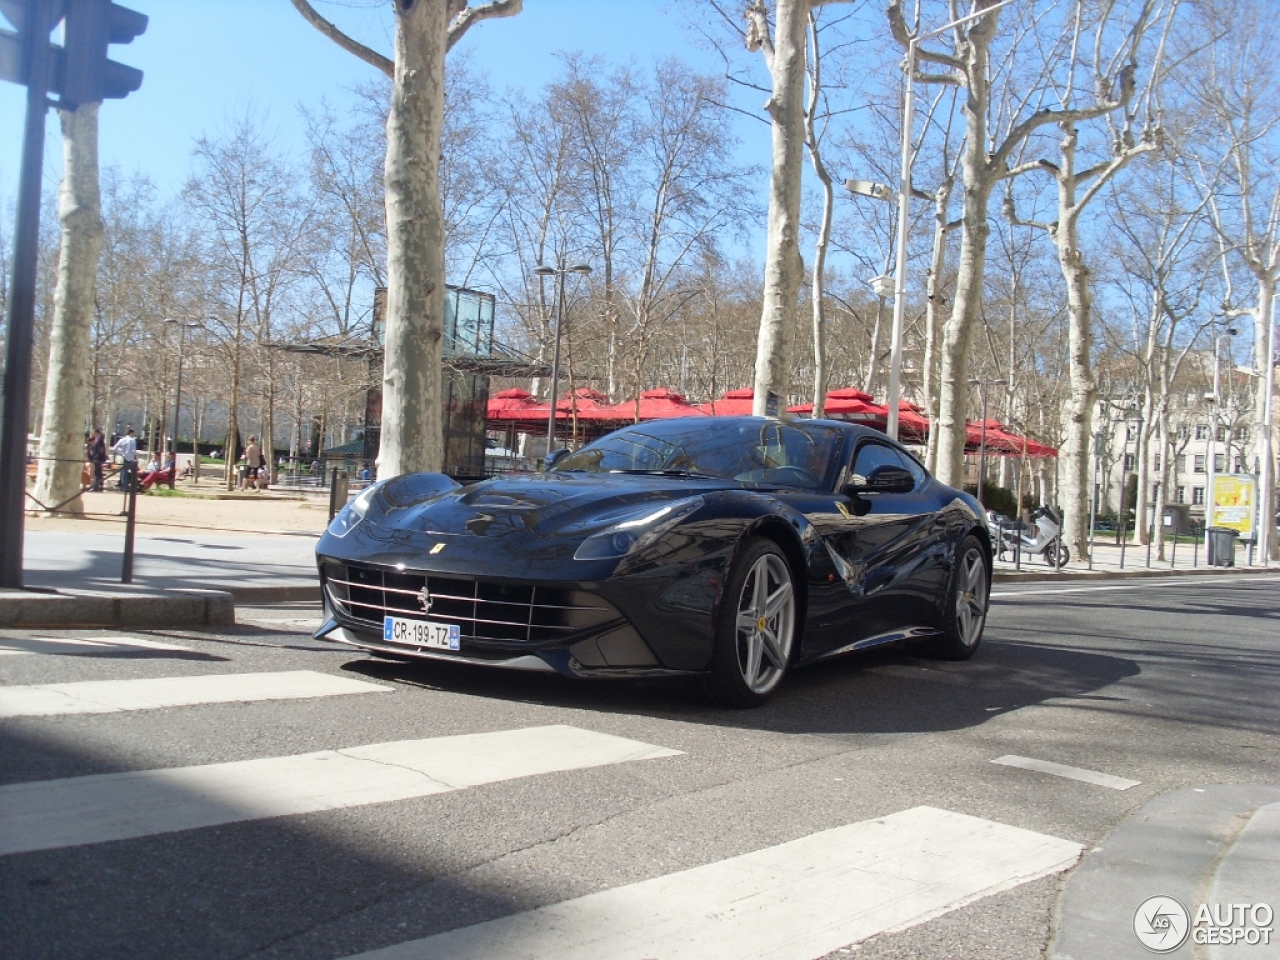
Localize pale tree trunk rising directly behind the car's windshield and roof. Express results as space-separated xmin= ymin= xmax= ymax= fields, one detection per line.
xmin=751 ymin=0 xmax=809 ymax=416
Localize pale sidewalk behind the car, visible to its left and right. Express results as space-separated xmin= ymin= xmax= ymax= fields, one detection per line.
xmin=0 ymin=490 xmax=1280 ymax=627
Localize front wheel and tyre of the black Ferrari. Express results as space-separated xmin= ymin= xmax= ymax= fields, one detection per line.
xmin=707 ymin=538 xmax=797 ymax=707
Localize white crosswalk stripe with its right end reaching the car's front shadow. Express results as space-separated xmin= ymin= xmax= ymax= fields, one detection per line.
xmin=0 ymin=669 xmax=392 ymax=719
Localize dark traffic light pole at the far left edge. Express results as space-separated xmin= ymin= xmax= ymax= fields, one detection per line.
xmin=0 ymin=0 xmax=54 ymax=590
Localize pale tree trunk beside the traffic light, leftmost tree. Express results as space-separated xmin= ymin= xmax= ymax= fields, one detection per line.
xmin=36 ymin=104 xmax=102 ymax=515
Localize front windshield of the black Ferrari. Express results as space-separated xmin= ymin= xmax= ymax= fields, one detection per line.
xmin=552 ymin=417 xmax=842 ymax=490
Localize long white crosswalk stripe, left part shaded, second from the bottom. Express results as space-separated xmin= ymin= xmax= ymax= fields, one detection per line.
xmin=0 ymin=726 xmax=680 ymax=855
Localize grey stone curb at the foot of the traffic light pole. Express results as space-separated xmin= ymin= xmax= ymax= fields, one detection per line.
xmin=0 ymin=590 xmax=236 ymax=630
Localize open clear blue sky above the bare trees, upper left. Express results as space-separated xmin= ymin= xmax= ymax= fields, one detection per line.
xmin=0 ymin=0 xmax=768 ymax=209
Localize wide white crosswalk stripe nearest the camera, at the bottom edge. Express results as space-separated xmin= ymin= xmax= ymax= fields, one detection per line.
xmin=349 ymin=806 xmax=1082 ymax=960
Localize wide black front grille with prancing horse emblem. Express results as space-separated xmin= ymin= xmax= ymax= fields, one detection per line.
xmin=324 ymin=561 xmax=621 ymax=644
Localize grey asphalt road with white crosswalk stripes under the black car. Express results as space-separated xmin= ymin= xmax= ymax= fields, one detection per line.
xmin=0 ymin=575 xmax=1280 ymax=960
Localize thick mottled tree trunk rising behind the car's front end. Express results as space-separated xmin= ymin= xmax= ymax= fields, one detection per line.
xmin=378 ymin=0 xmax=449 ymax=477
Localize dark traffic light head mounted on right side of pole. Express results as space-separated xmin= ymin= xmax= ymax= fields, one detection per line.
xmin=60 ymin=0 xmax=147 ymax=108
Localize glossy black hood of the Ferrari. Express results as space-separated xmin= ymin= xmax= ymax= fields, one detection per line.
xmin=366 ymin=474 xmax=741 ymax=538
